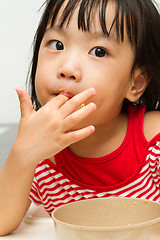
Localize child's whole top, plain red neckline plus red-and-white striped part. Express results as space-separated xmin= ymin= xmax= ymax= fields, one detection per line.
xmin=29 ymin=106 xmax=160 ymax=214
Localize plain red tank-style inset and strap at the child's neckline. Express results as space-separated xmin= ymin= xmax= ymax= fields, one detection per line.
xmin=55 ymin=106 xmax=148 ymax=187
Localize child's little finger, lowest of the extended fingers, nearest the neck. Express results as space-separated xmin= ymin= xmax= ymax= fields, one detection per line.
xmin=66 ymin=125 xmax=95 ymax=146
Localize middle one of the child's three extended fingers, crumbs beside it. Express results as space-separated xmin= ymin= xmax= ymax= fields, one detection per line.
xmin=64 ymin=103 xmax=96 ymax=132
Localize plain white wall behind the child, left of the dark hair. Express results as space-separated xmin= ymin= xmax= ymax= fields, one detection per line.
xmin=0 ymin=0 xmax=160 ymax=124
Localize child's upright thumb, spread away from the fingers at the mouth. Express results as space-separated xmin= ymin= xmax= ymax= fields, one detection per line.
xmin=16 ymin=88 xmax=34 ymax=117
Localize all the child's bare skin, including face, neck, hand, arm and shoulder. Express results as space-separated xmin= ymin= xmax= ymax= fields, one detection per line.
xmin=0 ymin=0 xmax=160 ymax=236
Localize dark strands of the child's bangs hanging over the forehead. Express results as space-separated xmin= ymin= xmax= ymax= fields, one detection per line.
xmin=46 ymin=0 xmax=141 ymax=46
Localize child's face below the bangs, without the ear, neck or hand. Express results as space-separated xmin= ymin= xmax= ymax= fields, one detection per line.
xmin=35 ymin=1 xmax=134 ymax=128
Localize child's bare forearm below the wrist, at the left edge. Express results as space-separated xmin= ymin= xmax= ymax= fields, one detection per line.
xmin=0 ymin=148 xmax=34 ymax=236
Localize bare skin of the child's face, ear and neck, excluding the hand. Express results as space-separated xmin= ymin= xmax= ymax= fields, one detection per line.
xmin=35 ymin=4 xmax=146 ymax=158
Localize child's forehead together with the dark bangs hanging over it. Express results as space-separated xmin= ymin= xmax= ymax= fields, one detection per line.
xmin=43 ymin=0 xmax=142 ymax=47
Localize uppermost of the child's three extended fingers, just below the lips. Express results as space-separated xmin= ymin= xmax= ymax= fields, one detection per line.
xmin=60 ymin=88 xmax=95 ymax=118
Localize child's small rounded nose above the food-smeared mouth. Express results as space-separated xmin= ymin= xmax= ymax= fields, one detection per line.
xmin=57 ymin=54 xmax=82 ymax=82
